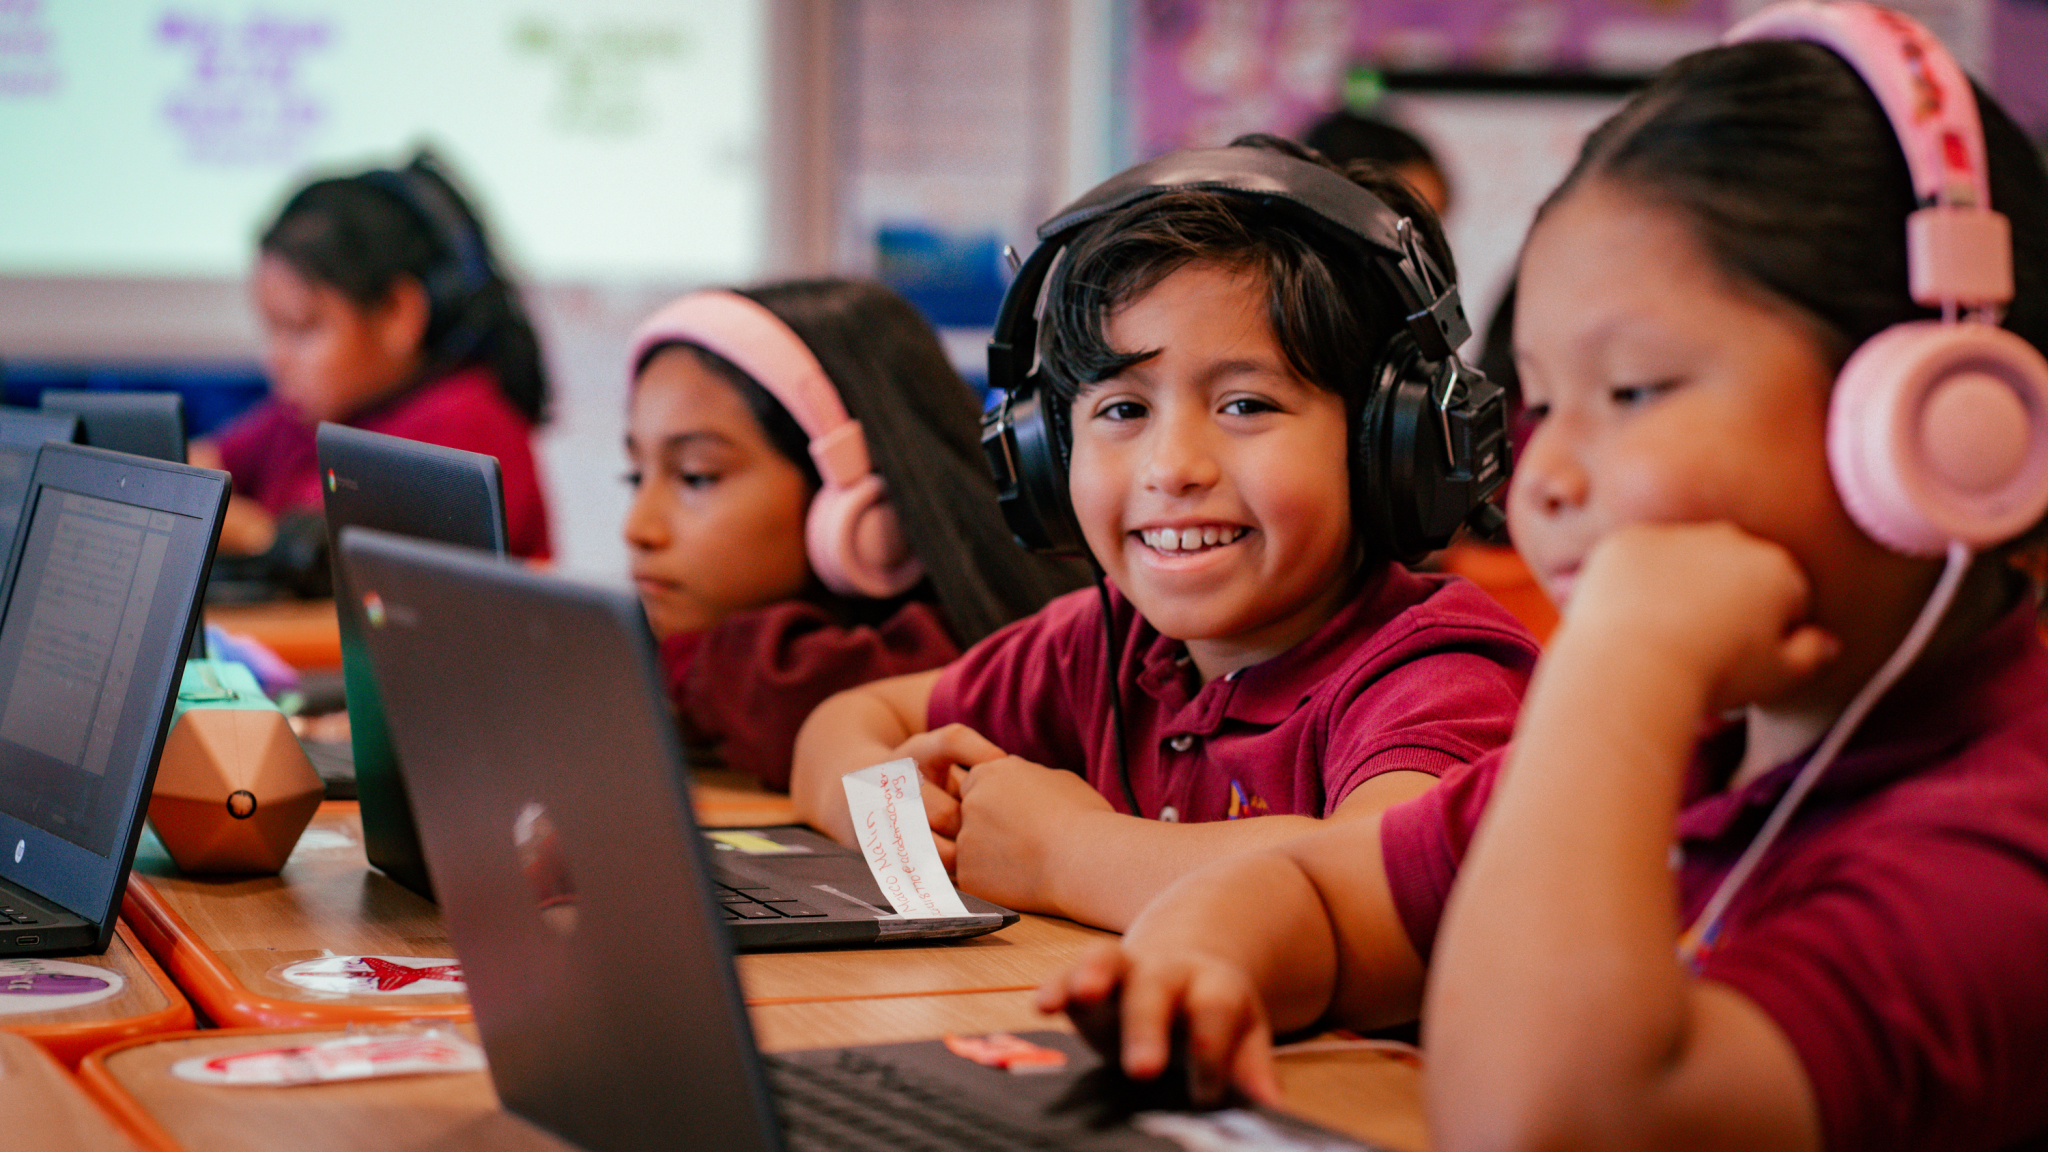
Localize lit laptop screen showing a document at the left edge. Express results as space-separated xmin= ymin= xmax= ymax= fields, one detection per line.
xmin=0 ymin=445 xmax=227 ymax=957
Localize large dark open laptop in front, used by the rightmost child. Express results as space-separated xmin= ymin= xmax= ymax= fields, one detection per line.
xmin=342 ymin=531 xmax=1360 ymax=1152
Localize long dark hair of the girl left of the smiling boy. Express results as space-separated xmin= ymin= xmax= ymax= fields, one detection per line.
xmin=635 ymin=279 xmax=1087 ymax=648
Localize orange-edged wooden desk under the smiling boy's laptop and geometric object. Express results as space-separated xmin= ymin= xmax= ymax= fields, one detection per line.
xmin=125 ymin=799 xmax=1108 ymax=1027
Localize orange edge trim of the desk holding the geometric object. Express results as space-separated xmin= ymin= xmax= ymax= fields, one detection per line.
xmin=121 ymin=875 xmax=469 ymax=1035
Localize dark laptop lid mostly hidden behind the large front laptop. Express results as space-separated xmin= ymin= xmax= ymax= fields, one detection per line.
xmin=321 ymin=424 xmax=506 ymax=900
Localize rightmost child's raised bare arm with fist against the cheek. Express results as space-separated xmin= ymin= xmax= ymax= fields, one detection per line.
xmin=1425 ymin=525 xmax=1833 ymax=1148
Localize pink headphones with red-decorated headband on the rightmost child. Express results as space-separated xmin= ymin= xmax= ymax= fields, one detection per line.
xmin=1724 ymin=0 xmax=2048 ymax=556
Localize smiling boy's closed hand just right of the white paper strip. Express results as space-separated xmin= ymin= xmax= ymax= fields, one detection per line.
xmin=954 ymin=756 xmax=1116 ymax=912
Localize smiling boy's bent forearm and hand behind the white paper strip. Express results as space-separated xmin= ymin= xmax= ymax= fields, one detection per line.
xmin=788 ymin=668 xmax=1004 ymax=852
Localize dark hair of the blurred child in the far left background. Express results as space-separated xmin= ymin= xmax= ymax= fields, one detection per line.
xmin=258 ymin=154 xmax=549 ymax=424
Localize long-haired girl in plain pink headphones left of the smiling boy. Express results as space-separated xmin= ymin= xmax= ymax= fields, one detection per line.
xmin=625 ymin=279 xmax=1081 ymax=789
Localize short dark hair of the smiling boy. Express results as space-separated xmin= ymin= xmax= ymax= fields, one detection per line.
xmin=1040 ymin=133 xmax=1458 ymax=433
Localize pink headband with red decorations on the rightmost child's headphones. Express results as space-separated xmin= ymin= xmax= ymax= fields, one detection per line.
xmin=1722 ymin=0 xmax=2013 ymax=307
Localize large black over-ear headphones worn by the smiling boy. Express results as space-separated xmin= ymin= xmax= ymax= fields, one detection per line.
xmin=981 ymin=148 xmax=1509 ymax=560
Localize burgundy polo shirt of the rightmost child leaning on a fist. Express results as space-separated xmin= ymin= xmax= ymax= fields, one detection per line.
xmin=1380 ymin=605 xmax=2048 ymax=1152
